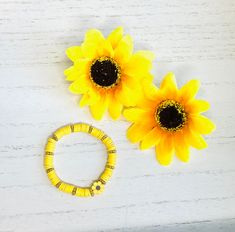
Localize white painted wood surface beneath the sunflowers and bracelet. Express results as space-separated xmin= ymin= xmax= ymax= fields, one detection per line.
xmin=0 ymin=0 xmax=235 ymax=232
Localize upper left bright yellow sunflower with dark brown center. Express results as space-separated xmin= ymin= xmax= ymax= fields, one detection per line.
xmin=64 ymin=27 xmax=154 ymax=120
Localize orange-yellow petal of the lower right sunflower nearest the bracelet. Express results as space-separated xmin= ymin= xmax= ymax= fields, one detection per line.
xmin=127 ymin=123 xmax=152 ymax=143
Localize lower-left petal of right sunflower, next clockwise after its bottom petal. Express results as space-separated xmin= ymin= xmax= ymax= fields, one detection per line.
xmin=140 ymin=127 xmax=161 ymax=150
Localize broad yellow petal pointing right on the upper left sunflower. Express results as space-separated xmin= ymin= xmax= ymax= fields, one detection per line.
xmin=123 ymin=53 xmax=152 ymax=78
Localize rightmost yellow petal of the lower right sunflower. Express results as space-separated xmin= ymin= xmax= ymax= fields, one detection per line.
xmin=190 ymin=115 xmax=215 ymax=134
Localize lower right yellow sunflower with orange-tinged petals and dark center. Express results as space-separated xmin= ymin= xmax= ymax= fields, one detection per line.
xmin=124 ymin=73 xmax=215 ymax=165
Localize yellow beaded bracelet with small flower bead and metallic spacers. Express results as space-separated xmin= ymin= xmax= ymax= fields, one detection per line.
xmin=44 ymin=123 xmax=117 ymax=197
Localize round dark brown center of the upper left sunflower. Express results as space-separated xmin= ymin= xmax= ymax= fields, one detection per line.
xmin=90 ymin=57 xmax=120 ymax=88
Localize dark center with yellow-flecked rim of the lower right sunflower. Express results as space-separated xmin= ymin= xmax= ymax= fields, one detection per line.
xmin=156 ymin=100 xmax=187 ymax=132
